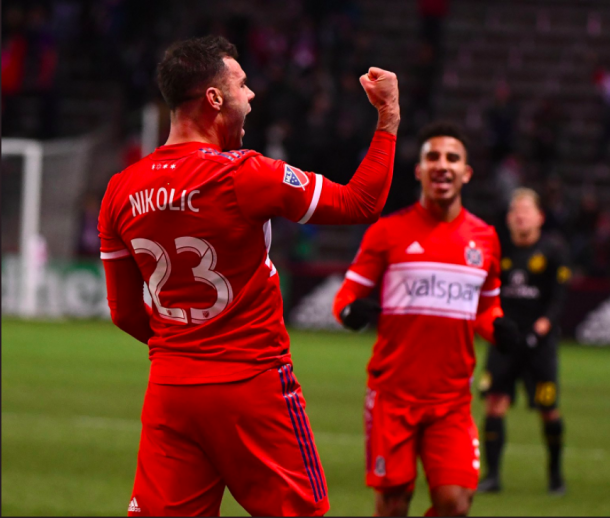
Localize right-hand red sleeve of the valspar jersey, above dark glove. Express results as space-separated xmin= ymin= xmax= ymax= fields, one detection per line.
xmin=475 ymin=230 xmax=504 ymax=343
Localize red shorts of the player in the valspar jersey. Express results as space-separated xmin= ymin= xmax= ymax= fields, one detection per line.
xmin=364 ymin=388 xmax=480 ymax=491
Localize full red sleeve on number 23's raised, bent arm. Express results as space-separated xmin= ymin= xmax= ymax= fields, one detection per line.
xmin=235 ymin=131 xmax=396 ymax=224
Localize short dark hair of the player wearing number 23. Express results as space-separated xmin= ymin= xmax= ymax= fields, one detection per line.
xmin=157 ymin=35 xmax=237 ymax=111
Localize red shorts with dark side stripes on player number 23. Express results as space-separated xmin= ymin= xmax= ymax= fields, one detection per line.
xmin=129 ymin=365 xmax=329 ymax=516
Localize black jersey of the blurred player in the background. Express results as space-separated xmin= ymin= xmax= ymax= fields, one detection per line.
xmin=500 ymin=236 xmax=571 ymax=332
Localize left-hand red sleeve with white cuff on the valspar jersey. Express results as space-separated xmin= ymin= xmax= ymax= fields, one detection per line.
xmin=333 ymin=220 xmax=387 ymax=322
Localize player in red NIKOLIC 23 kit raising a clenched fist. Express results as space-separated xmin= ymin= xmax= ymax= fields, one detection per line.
xmin=99 ymin=36 xmax=400 ymax=516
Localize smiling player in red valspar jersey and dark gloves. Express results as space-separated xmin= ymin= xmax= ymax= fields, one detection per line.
xmin=333 ymin=123 xmax=517 ymax=516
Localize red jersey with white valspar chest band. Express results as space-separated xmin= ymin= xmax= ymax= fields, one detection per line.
xmin=337 ymin=203 xmax=500 ymax=403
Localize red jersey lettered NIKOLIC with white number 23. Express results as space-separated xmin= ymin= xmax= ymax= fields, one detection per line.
xmin=99 ymin=132 xmax=395 ymax=384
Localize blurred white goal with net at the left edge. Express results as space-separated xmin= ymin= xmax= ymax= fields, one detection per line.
xmin=1 ymin=137 xmax=108 ymax=318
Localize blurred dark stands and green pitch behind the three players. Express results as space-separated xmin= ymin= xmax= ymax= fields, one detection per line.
xmin=1 ymin=0 xmax=610 ymax=515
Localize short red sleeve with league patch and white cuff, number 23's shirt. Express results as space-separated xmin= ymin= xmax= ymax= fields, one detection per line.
xmin=235 ymin=155 xmax=323 ymax=223
